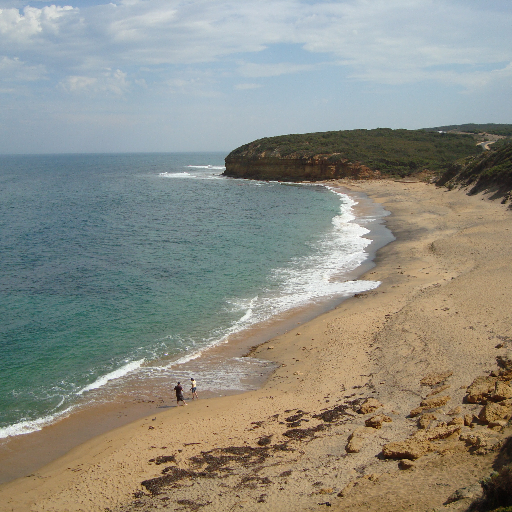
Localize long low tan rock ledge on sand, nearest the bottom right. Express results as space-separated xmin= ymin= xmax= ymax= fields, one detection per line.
xmin=382 ymin=425 xmax=462 ymax=460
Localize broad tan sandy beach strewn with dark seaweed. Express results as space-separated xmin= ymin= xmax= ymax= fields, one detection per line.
xmin=0 ymin=180 xmax=512 ymax=512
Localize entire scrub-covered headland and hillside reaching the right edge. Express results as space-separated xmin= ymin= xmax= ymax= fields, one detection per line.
xmin=224 ymin=124 xmax=512 ymax=202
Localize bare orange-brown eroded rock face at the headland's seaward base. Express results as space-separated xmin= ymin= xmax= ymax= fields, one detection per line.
xmin=223 ymin=153 xmax=380 ymax=181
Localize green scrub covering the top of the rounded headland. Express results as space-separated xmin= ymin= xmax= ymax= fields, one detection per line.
xmin=225 ymin=128 xmax=482 ymax=181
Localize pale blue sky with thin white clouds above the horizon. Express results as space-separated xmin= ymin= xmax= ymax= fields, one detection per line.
xmin=0 ymin=0 xmax=512 ymax=154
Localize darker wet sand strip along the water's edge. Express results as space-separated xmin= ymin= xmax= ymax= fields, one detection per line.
xmin=0 ymin=184 xmax=393 ymax=485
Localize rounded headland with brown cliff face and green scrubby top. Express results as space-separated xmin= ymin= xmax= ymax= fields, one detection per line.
xmin=224 ymin=128 xmax=481 ymax=181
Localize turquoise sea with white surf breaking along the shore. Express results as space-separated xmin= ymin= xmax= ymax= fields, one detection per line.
xmin=0 ymin=153 xmax=384 ymax=437
